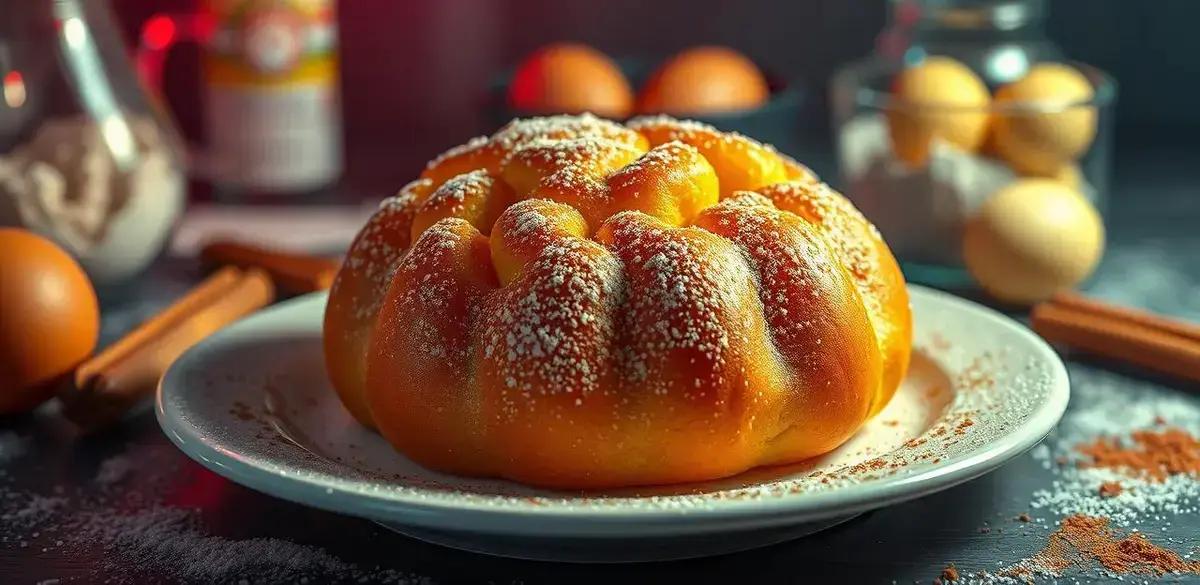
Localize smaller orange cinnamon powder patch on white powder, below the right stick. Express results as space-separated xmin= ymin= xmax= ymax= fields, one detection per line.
xmin=1078 ymin=428 xmax=1200 ymax=482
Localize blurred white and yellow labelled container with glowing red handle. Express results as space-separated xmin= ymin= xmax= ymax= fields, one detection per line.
xmin=139 ymin=0 xmax=342 ymax=195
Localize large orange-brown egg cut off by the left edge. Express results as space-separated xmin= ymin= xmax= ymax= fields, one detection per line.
xmin=0 ymin=228 xmax=100 ymax=414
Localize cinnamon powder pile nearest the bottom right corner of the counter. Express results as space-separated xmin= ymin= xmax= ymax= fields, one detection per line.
xmin=1013 ymin=514 xmax=1200 ymax=577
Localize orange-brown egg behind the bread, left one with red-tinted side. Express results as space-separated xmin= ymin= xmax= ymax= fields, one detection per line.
xmin=509 ymin=43 xmax=634 ymax=117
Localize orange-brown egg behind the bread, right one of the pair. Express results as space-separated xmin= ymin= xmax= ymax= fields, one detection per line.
xmin=637 ymin=47 xmax=770 ymax=115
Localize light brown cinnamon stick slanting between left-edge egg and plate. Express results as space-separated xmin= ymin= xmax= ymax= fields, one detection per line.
xmin=60 ymin=267 xmax=275 ymax=428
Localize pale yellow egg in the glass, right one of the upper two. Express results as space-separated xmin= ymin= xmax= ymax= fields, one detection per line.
xmin=992 ymin=64 xmax=1096 ymax=176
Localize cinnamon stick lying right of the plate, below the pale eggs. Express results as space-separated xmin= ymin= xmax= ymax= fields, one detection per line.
xmin=1032 ymin=293 xmax=1200 ymax=381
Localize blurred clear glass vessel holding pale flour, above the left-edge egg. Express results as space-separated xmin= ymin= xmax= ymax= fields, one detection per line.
xmin=0 ymin=0 xmax=185 ymax=290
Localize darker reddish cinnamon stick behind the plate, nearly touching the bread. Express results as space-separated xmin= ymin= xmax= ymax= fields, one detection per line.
xmin=200 ymin=240 xmax=338 ymax=295
